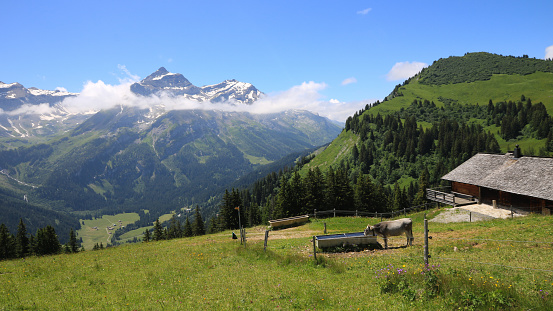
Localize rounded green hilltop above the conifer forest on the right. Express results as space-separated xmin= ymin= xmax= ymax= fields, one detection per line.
xmin=371 ymin=53 xmax=553 ymax=113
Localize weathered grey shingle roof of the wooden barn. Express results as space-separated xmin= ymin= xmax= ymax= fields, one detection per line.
xmin=442 ymin=153 xmax=553 ymax=201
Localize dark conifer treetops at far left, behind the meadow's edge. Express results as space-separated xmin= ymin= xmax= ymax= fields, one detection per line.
xmin=0 ymin=219 xmax=82 ymax=260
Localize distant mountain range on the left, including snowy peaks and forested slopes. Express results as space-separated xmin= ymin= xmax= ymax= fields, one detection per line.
xmin=0 ymin=67 xmax=341 ymax=239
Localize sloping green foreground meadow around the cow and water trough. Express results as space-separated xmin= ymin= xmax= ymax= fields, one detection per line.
xmin=0 ymin=208 xmax=553 ymax=310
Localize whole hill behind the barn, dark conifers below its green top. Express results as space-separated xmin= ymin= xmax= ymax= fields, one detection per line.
xmin=209 ymin=53 xmax=553 ymax=232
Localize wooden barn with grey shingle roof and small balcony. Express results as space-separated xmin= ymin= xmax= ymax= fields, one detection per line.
xmin=427 ymin=146 xmax=553 ymax=215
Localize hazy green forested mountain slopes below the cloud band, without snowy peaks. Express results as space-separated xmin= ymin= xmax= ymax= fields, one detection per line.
xmin=0 ymin=107 xmax=340 ymax=241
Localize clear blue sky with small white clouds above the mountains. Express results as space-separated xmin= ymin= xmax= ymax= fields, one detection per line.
xmin=0 ymin=0 xmax=553 ymax=121
